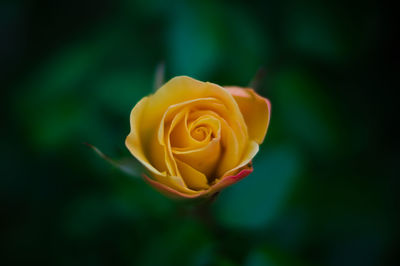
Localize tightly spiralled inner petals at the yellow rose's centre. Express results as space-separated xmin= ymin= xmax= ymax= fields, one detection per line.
xmin=164 ymin=103 xmax=223 ymax=182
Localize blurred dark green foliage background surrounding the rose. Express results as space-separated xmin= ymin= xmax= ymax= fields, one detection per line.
xmin=0 ymin=0 xmax=399 ymax=266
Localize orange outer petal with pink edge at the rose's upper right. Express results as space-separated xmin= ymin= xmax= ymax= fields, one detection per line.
xmin=226 ymin=87 xmax=271 ymax=144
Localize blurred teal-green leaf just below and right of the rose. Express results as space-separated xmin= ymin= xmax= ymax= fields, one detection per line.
xmin=215 ymin=146 xmax=301 ymax=230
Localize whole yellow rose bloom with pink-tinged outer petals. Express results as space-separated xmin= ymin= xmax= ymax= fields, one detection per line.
xmin=125 ymin=76 xmax=270 ymax=198
